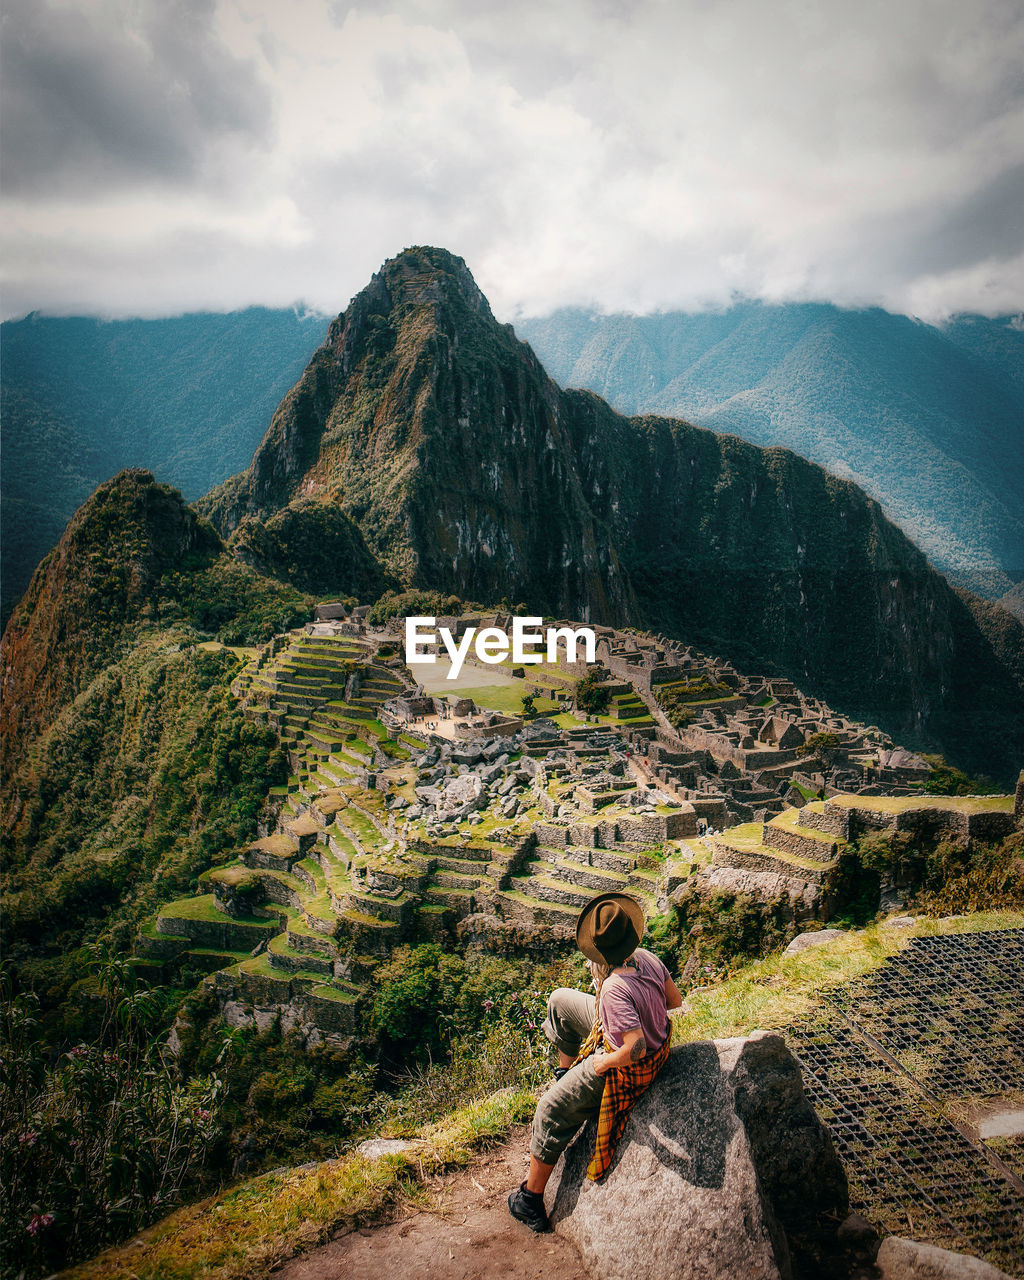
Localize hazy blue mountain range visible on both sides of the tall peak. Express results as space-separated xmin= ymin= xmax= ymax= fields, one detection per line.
xmin=0 ymin=296 xmax=1024 ymax=620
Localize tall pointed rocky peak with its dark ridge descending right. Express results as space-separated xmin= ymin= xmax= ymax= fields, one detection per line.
xmin=201 ymin=248 xmax=1024 ymax=772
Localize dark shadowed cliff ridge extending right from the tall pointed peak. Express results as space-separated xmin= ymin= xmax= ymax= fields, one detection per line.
xmin=564 ymin=392 xmax=1024 ymax=776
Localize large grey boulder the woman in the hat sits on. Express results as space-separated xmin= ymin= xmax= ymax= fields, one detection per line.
xmin=547 ymin=1032 xmax=847 ymax=1280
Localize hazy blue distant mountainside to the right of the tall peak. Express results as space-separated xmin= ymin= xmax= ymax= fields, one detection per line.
xmin=516 ymin=302 xmax=1024 ymax=605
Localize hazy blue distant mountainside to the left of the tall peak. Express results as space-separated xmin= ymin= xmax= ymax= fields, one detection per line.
xmin=0 ymin=307 xmax=328 ymax=621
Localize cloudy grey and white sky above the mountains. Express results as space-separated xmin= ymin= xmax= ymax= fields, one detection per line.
xmin=0 ymin=0 xmax=1024 ymax=319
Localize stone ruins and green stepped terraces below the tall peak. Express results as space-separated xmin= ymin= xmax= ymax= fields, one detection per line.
xmin=137 ymin=618 xmax=1012 ymax=1039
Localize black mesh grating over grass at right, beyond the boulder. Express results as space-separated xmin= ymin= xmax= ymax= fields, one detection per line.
xmin=787 ymin=931 xmax=1024 ymax=1275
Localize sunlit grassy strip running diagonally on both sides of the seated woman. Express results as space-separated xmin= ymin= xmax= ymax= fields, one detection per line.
xmin=64 ymin=911 xmax=1024 ymax=1280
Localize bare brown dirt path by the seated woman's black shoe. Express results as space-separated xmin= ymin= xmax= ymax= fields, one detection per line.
xmin=274 ymin=1126 xmax=590 ymax=1280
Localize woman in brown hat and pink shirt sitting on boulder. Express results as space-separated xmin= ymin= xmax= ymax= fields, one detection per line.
xmin=508 ymin=893 xmax=682 ymax=1231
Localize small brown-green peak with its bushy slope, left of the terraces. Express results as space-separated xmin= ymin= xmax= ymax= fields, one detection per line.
xmin=0 ymin=471 xmax=311 ymax=1034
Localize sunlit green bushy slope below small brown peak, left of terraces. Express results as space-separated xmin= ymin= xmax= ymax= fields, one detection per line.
xmin=3 ymin=628 xmax=287 ymax=1034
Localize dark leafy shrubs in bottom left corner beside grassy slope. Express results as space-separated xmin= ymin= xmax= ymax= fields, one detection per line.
xmin=0 ymin=950 xmax=220 ymax=1275
